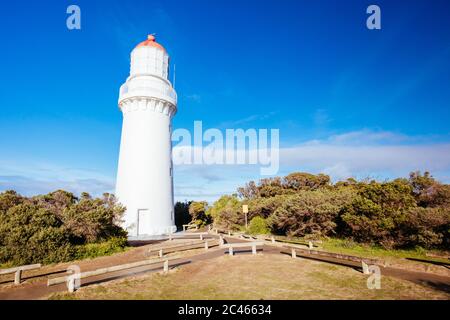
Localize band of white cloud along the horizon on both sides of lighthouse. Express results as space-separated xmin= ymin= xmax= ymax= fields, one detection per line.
xmin=0 ymin=130 xmax=450 ymax=201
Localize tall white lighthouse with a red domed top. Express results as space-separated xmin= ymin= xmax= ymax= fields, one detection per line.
xmin=116 ymin=35 xmax=177 ymax=238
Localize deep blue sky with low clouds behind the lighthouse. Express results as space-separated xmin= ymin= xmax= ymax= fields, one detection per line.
xmin=0 ymin=0 xmax=450 ymax=200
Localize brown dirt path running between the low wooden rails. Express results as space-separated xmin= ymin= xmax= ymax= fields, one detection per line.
xmin=0 ymin=237 xmax=450 ymax=300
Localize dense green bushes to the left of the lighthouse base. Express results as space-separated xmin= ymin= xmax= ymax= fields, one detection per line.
xmin=0 ymin=190 xmax=126 ymax=265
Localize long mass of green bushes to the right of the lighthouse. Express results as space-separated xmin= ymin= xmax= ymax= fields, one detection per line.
xmin=230 ymin=172 xmax=450 ymax=250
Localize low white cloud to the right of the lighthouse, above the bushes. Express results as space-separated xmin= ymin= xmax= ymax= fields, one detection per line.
xmin=171 ymin=130 xmax=450 ymax=201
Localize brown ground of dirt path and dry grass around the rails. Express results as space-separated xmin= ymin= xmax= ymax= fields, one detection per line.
xmin=0 ymin=235 xmax=450 ymax=300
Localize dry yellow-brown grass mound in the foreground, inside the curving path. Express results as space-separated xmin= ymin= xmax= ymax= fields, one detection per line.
xmin=50 ymin=253 xmax=450 ymax=300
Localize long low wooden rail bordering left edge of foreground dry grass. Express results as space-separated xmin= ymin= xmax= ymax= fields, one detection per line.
xmin=47 ymin=259 xmax=169 ymax=292
